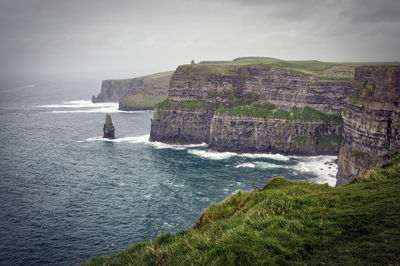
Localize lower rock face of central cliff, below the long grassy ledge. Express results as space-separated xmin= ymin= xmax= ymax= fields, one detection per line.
xmin=209 ymin=115 xmax=342 ymax=155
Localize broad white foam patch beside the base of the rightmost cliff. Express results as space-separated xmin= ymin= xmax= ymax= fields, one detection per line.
xmin=290 ymin=156 xmax=337 ymax=186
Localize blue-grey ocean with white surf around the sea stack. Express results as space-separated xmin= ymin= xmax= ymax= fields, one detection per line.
xmin=0 ymin=81 xmax=337 ymax=265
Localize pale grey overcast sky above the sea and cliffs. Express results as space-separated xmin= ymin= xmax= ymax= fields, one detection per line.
xmin=0 ymin=0 xmax=400 ymax=78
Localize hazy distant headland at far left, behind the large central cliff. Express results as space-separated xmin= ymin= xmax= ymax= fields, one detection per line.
xmin=92 ymin=71 xmax=173 ymax=110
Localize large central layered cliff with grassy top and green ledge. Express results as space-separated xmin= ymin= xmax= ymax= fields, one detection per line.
xmin=150 ymin=58 xmax=350 ymax=155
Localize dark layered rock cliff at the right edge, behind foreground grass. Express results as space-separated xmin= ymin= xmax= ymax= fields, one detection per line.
xmin=336 ymin=66 xmax=400 ymax=185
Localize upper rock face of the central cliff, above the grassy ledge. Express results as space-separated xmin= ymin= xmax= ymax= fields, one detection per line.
xmin=169 ymin=65 xmax=350 ymax=113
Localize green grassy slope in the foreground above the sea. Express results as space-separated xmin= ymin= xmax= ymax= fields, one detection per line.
xmin=87 ymin=156 xmax=400 ymax=265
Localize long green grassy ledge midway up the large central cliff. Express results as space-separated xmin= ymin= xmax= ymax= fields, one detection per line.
xmin=217 ymin=103 xmax=341 ymax=121
